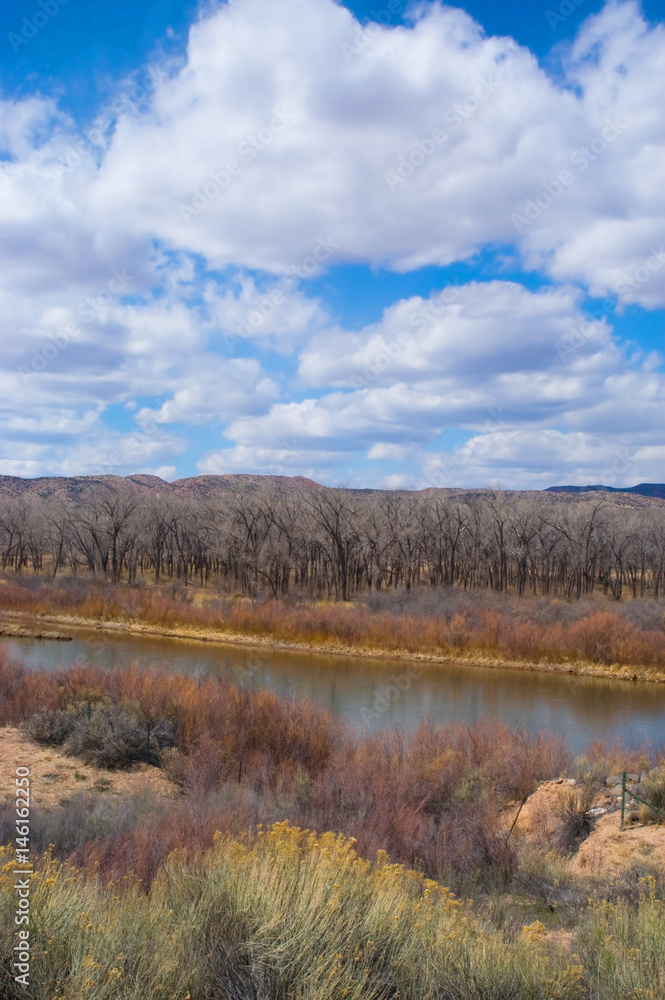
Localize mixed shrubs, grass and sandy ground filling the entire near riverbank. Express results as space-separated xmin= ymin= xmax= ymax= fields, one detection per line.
xmin=0 ymin=649 xmax=665 ymax=1000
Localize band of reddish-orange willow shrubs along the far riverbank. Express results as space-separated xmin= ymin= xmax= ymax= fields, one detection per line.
xmin=5 ymin=581 xmax=665 ymax=670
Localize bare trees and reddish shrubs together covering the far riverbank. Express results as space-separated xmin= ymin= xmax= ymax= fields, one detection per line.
xmin=0 ymin=476 xmax=665 ymax=682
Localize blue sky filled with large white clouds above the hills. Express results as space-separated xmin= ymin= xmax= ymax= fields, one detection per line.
xmin=0 ymin=0 xmax=665 ymax=489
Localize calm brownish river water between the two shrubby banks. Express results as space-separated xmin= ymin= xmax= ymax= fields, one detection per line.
xmin=1 ymin=629 xmax=665 ymax=751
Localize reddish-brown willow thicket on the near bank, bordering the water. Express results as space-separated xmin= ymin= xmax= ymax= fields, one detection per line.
xmin=0 ymin=657 xmax=570 ymax=882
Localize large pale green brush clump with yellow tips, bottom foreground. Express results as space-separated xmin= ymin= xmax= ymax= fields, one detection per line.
xmin=0 ymin=823 xmax=584 ymax=1000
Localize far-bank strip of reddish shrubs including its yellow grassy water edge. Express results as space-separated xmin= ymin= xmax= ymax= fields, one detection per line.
xmin=0 ymin=576 xmax=665 ymax=683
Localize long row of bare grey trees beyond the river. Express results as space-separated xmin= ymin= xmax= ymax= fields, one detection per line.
xmin=0 ymin=485 xmax=665 ymax=600
